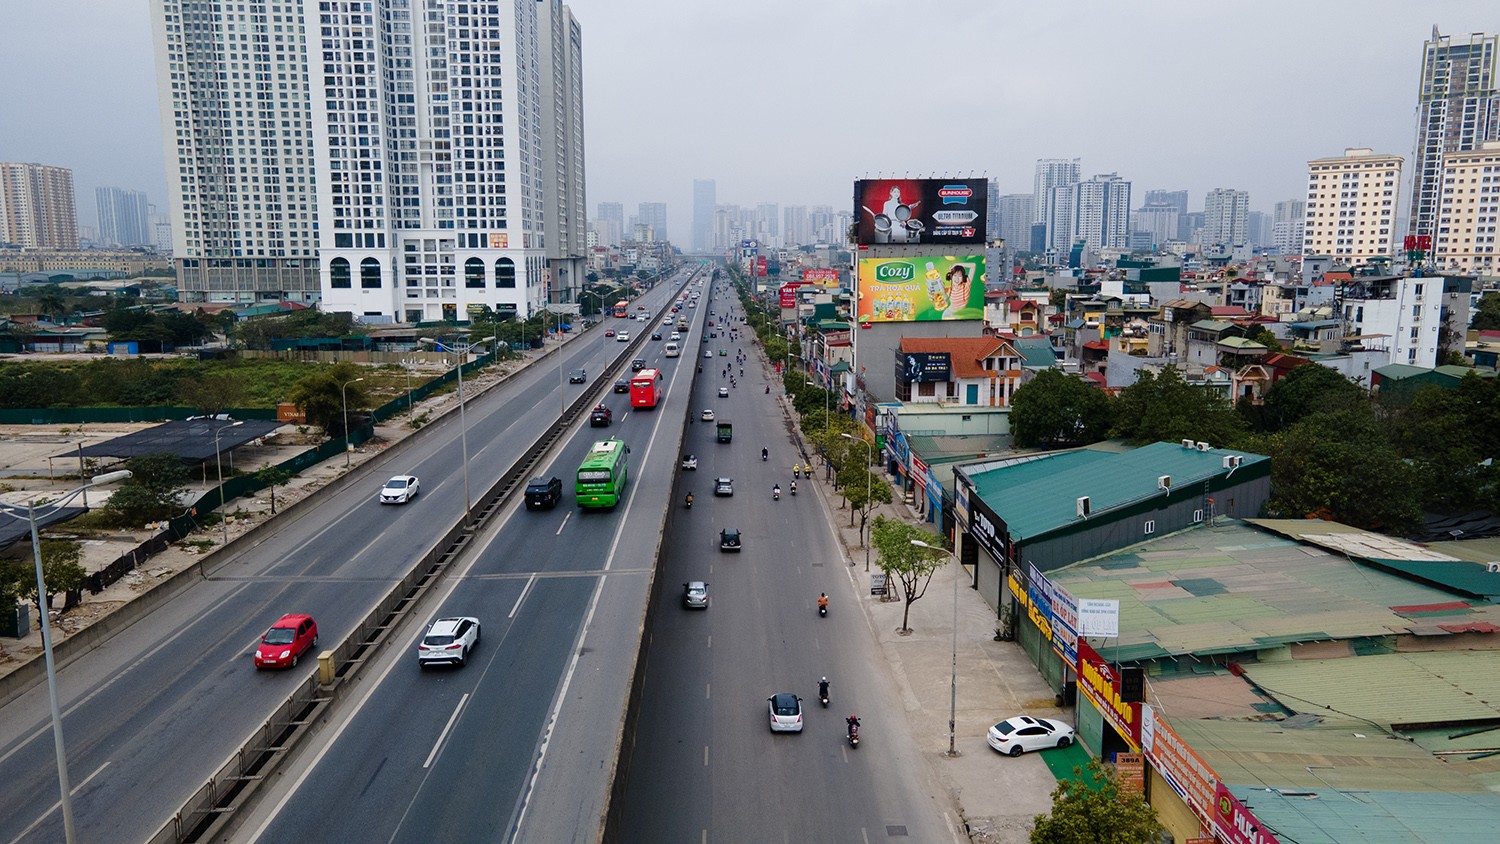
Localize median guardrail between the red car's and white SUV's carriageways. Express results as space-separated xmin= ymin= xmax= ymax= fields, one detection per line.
xmin=147 ymin=273 xmax=698 ymax=844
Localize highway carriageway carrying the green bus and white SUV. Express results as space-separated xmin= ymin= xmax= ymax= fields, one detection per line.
xmin=236 ymin=286 xmax=707 ymax=843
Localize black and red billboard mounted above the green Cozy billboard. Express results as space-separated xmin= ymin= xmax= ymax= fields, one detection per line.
xmin=854 ymin=178 xmax=990 ymax=246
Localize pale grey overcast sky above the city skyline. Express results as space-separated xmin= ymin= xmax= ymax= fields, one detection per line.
xmin=0 ymin=0 xmax=1500 ymax=241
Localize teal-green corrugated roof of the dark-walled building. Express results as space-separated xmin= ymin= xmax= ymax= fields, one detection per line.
xmin=971 ymin=442 xmax=1269 ymax=538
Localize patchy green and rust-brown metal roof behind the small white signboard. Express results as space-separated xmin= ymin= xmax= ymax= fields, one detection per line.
xmin=1050 ymin=521 xmax=1500 ymax=659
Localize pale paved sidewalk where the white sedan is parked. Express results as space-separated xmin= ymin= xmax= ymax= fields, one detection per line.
xmin=780 ymin=396 xmax=1082 ymax=844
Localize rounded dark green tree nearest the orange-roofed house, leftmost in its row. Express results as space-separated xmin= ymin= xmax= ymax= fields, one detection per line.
xmin=1011 ymin=369 xmax=1115 ymax=448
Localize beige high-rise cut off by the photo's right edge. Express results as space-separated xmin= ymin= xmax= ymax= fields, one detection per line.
xmin=1433 ymin=141 xmax=1500 ymax=273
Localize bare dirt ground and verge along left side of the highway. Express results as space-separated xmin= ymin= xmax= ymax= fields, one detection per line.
xmin=0 ymin=331 xmax=573 ymax=676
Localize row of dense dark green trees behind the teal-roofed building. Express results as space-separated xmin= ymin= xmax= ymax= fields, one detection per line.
xmin=1011 ymin=358 xmax=1500 ymax=534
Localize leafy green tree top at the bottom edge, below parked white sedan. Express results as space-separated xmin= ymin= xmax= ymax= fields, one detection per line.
xmin=1031 ymin=759 xmax=1164 ymax=844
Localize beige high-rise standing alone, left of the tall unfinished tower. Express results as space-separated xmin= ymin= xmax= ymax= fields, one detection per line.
xmin=1302 ymin=147 xmax=1406 ymax=262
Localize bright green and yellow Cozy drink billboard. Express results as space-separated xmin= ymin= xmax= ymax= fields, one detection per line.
xmin=855 ymin=255 xmax=984 ymax=322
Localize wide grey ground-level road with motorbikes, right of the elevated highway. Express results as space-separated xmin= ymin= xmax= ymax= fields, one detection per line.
xmin=620 ymin=286 xmax=957 ymax=843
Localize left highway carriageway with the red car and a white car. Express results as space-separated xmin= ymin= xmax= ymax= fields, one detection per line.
xmin=0 ymin=272 xmax=696 ymax=843
